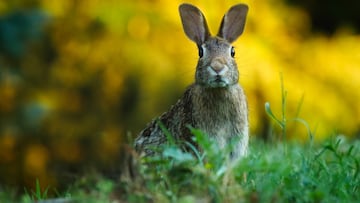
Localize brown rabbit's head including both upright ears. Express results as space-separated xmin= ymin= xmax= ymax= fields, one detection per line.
xmin=179 ymin=4 xmax=248 ymax=88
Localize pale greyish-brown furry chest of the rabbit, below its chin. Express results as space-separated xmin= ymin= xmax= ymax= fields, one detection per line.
xmin=192 ymin=84 xmax=248 ymax=148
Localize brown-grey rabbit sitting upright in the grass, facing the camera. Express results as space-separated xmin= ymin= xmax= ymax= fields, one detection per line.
xmin=135 ymin=3 xmax=249 ymax=159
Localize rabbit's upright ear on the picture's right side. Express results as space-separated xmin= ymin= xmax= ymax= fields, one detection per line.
xmin=217 ymin=4 xmax=249 ymax=43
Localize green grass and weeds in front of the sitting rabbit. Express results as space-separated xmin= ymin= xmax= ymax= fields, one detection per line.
xmin=0 ymin=134 xmax=360 ymax=202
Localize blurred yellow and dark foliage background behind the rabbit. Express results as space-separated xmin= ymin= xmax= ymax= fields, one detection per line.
xmin=0 ymin=0 xmax=360 ymax=193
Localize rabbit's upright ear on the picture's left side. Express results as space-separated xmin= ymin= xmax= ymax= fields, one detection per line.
xmin=179 ymin=4 xmax=210 ymax=46
